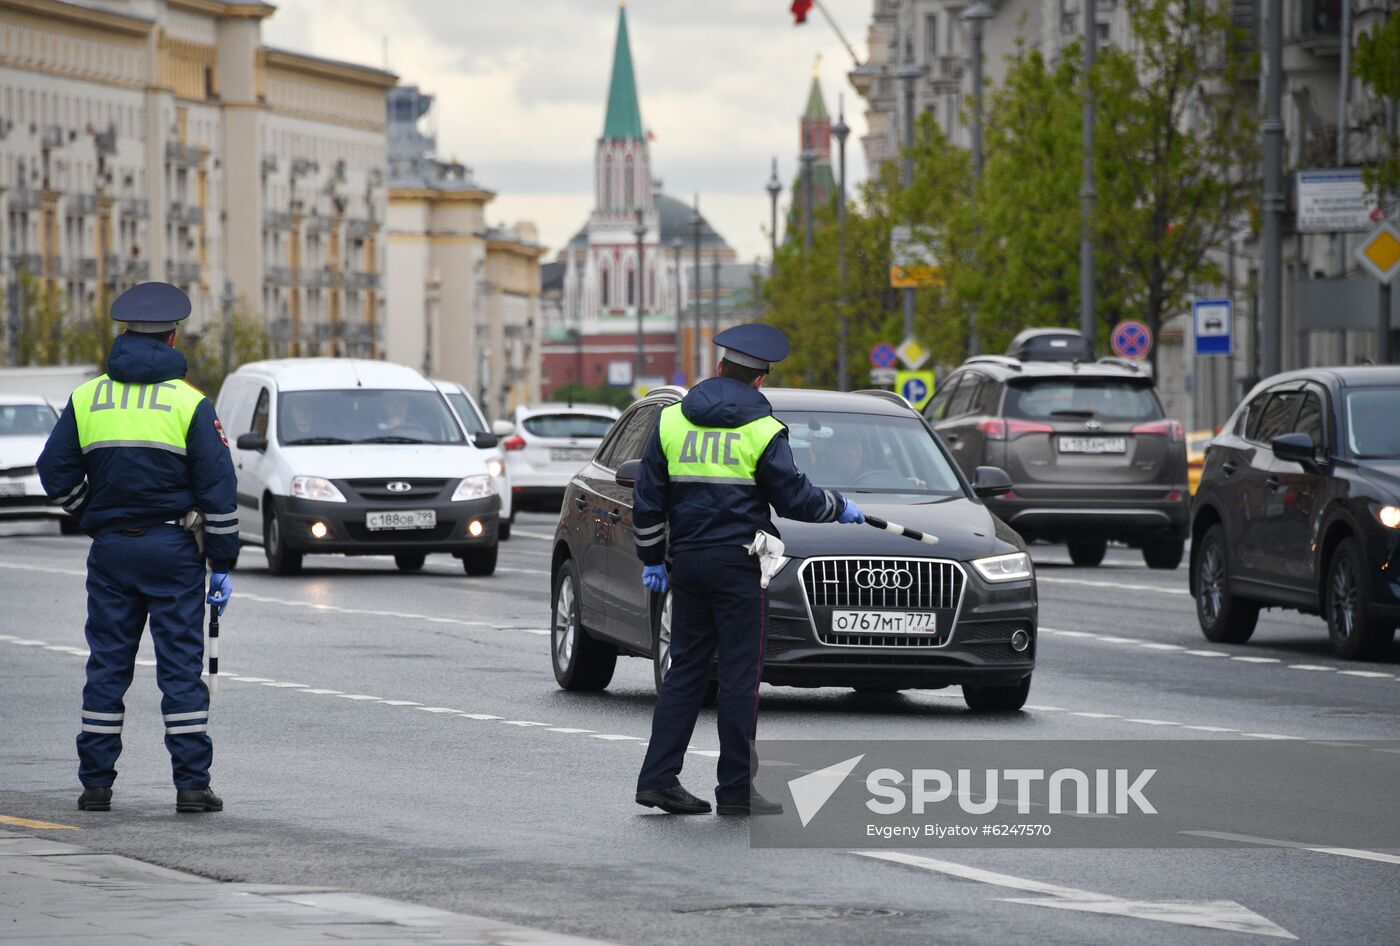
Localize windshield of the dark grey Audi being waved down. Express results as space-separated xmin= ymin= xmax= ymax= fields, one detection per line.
xmin=777 ymin=410 xmax=962 ymax=495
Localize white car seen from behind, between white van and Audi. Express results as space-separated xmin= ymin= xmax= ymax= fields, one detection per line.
xmin=493 ymin=403 xmax=622 ymax=512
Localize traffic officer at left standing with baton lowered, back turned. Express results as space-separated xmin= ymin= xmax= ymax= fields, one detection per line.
xmin=39 ymin=283 xmax=238 ymax=812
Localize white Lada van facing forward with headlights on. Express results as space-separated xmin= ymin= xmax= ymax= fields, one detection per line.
xmin=218 ymin=358 xmax=500 ymax=575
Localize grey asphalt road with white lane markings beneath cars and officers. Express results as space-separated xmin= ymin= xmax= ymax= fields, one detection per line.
xmin=0 ymin=516 xmax=1400 ymax=946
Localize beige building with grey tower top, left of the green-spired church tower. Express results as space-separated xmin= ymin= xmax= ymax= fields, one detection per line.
xmin=385 ymin=85 xmax=545 ymax=418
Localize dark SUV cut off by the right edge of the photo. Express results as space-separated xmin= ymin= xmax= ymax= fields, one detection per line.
xmin=1191 ymin=365 xmax=1400 ymax=659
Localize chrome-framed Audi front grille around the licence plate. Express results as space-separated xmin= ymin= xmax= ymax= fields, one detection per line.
xmin=802 ymin=557 xmax=966 ymax=647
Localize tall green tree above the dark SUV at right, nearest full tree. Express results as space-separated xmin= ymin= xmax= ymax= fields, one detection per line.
xmin=1092 ymin=0 xmax=1257 ymax=367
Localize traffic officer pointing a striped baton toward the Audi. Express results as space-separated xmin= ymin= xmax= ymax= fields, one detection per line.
xmin=633 ymin=325 xmax=864 ymax=814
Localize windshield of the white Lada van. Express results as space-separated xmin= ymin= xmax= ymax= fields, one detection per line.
xmin=277 ymin=388 xmax=465 ymax=446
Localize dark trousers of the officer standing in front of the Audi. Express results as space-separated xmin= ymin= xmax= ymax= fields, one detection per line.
xmin=637 ymin=546 xmax=767 ymax=803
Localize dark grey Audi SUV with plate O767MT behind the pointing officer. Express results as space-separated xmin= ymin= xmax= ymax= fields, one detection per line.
xmin=552 ymin=388 xmax=1036 ymax=711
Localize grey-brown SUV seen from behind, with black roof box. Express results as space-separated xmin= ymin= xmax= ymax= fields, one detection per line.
xmin=924 ymin=355 xmax=1190 ymax=568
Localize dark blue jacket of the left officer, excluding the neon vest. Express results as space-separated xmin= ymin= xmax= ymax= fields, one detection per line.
xmin=39 ymin=334 xmax=238 ymax=571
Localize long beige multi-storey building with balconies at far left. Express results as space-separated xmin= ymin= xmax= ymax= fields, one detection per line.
xmin=0 ymin=0 xmax=396 ymax=357
